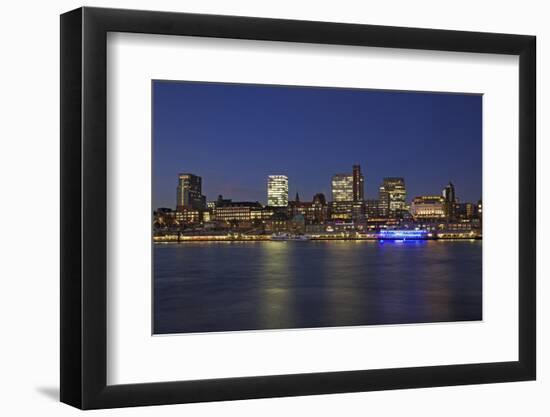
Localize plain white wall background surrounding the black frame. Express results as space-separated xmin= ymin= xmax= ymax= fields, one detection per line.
xmin=0 ymin=0 xmax=550 ymax=416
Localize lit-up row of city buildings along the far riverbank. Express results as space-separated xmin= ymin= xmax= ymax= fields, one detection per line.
xmin=153 ymin=165 xmax=482 ymax=237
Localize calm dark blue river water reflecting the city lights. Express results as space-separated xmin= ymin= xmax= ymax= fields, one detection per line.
xmin=154 ymin=241 xmax=482 ymax=334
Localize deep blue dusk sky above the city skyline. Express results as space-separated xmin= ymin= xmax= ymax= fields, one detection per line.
xmin=153 ymin=81 xmax=482 ymax=208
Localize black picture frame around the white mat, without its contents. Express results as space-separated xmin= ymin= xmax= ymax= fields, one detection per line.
xmin=60 ymin=7 xmax=536 ymax=409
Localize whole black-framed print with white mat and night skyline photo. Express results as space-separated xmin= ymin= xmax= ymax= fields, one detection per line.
xmin=61 ymin=8 xmax=536 ymax=409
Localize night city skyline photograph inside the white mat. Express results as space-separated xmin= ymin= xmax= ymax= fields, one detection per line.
xmin=151 ymin=80 xmax=483 ymax=335
